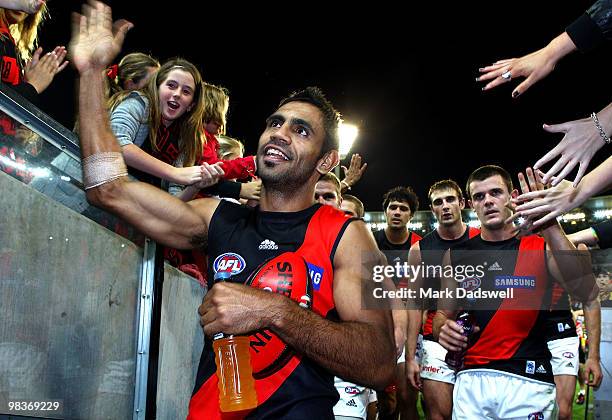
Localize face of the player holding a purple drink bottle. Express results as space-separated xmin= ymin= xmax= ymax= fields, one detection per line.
xmin=470 ymin=175 xmax=512 ymax=230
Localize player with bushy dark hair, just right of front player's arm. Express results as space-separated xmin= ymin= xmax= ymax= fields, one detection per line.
xmin=374 ymin=187 xmax=421 ymax=419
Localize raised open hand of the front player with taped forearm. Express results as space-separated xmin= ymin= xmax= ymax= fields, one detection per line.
xmin=68 ymin=0 xmax=133 ymax=74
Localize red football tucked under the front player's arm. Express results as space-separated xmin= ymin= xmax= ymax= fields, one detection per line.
xmin=247 ymin=252 xmax=312 ymax=379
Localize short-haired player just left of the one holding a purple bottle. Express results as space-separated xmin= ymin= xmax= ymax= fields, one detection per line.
xmin=406 ymin=179 xmax=480 ymax=420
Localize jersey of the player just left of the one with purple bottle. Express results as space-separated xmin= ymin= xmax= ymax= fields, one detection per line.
xmin=418 ymin=226 xmax=480 ymax=341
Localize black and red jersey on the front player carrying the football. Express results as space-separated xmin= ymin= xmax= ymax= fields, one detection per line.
xmin=188 ymin=201 xmax=356 ymax=420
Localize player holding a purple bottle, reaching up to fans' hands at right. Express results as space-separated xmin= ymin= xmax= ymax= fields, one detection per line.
xmin=433 ymin=165 xmax=597 ymax=419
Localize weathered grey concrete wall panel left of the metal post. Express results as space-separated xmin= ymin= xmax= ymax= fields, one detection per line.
xmin=0 ymin=172 xmax=142 ymax=419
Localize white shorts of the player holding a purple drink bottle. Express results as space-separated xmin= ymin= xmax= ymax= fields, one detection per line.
xmin=453 ymin=369 xmax=558 ymax=420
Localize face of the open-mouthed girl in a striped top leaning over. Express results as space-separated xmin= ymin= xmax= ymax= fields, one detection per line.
xmin=159 ymin=69 xmax=195 ymax=127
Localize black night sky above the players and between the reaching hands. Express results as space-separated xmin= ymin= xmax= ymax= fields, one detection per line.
xmin=34 ymin=0 xmax=612 ymax=211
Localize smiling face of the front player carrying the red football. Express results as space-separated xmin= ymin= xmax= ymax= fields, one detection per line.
xmin=257 ymin=102 xmax=331 ymax=188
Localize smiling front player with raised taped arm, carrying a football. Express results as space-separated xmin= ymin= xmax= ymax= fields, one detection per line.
xmin=70 ymin=0 xmax=393 ymax=420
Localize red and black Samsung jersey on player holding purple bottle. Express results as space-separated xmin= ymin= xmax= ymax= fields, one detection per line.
xmin=451 ymin=235 xmax=554 ymax=383
